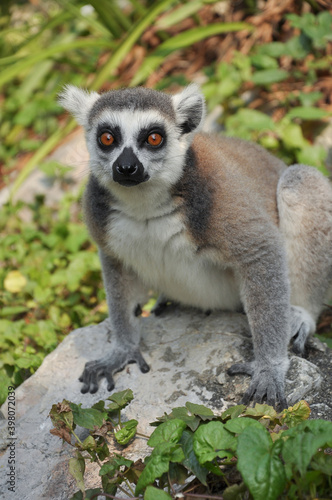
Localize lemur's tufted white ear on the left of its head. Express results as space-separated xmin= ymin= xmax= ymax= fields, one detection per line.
xmin=58 ymin=85 xmax=99 ymax=127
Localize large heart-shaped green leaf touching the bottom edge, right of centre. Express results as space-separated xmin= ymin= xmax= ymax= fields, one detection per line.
xmin=237 ymin=426 xmax=286 ymax=500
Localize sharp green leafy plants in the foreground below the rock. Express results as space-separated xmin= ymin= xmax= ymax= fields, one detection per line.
xmin=50 ymin=390 xmax=332 ymax=500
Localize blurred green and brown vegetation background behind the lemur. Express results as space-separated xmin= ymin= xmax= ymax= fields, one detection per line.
xmin=0 ymin=0 xmax=332 ymax=402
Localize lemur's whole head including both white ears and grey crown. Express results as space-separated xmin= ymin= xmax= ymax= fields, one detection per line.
xmin=60 ymin=86 xmax=204 ymax=189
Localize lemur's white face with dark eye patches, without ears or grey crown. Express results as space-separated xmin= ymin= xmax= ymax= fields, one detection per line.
xmin=87 ymin=110 xmax=179 ymax=187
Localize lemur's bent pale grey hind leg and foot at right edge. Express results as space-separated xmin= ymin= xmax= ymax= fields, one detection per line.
xmin=277 ymin=165 xmax=332 ymax=354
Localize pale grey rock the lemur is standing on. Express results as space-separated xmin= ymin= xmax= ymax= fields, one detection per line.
xmin=0 ymin=309 xmax=328 ymax=500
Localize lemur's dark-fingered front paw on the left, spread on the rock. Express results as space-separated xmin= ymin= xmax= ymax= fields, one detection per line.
xmin=79 ymin=348 xmax=150 ymax=394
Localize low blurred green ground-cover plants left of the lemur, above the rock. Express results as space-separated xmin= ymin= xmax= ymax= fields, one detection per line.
xmin=0 ymin=196 xmax=107 ymax=403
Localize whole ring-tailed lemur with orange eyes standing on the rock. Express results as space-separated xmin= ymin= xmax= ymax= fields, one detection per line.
xmin=60 ymin=84 xmax=332 ymax=407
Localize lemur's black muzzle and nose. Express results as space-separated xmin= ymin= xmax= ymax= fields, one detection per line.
xmin=112 ymin=148 xmax=149 ymax=187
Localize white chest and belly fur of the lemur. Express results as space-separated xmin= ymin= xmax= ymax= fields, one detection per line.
xmin=108 ymin=212 xmax=240 ymax=310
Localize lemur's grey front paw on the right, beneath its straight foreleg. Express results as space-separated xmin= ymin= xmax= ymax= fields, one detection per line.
xmin=228 ymin=362 xmax=287 ymax=409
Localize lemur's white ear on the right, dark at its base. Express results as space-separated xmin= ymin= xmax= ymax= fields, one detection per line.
xmin=172 ymin=83 xmax=205 ymax=134
